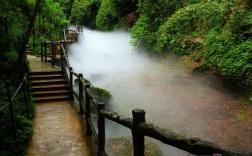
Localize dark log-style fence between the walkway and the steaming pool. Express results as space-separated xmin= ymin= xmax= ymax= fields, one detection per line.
xmin=41 ymin=29 xmax=252 ymax=156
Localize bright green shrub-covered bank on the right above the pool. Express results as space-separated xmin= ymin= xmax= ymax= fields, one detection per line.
xmin=130 ymin=0 xmax=252 ymax=86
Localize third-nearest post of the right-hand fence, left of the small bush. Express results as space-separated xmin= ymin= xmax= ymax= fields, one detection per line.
xmin=85 ymin=83 xmax=92 ymax=135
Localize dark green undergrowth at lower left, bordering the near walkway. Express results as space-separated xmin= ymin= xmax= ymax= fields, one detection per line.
xmin=0 ymin=84 xmax=34 ymax=155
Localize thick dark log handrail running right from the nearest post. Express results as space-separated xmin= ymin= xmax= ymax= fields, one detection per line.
xmin=139 ymin=123 xmax=251 ymax=156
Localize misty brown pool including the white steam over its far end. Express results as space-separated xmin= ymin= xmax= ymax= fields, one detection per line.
xmin=69 ymin=29 xmax=251 ymax=155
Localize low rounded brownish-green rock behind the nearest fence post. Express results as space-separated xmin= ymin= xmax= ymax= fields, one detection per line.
xmin=106 ymin=137 xmax=163 ymax=156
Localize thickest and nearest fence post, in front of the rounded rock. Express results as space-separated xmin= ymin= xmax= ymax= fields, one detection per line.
xmin=132 ymin=109 xmax=145 ymax=156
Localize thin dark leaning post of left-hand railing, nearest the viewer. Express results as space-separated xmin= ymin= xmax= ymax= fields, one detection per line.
xmin=6 ymin=83 xmax=18 ymax=149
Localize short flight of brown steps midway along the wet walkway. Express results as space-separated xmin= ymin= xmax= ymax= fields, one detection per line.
xmin=29 ymin=71 xmax=70 ymax=103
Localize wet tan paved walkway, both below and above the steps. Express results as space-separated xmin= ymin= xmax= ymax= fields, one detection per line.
xmin=26 ymin=55 xmax=97 ymax=156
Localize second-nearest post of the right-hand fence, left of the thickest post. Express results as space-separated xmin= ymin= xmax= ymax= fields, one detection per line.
xmin=97 ymin=103 xmax=105 ymax=156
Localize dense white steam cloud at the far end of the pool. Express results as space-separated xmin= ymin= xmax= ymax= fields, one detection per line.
xmin=69 ymin=29 xmax=148 ymax=84
